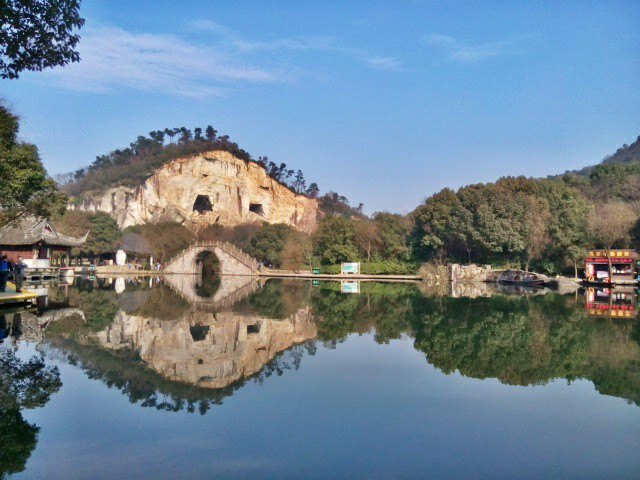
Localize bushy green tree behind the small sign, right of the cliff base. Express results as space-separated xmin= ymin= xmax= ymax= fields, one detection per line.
xmin=314 ymin=215 xmax=359 ymax=265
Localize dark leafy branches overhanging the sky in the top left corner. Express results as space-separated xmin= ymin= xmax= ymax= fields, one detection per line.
xmin=0 ymin=0 xmax=84 ymax=78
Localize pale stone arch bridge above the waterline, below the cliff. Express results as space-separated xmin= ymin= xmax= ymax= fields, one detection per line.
xmin=165 ymin=241 xmax=258 ymax=276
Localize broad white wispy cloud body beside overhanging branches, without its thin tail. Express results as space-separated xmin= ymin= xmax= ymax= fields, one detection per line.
xmin=48 ymin=27 xmax=286 ymax=97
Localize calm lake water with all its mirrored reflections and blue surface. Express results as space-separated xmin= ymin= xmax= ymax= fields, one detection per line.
xmin=0 ymin=277 xmax=640 ymax=479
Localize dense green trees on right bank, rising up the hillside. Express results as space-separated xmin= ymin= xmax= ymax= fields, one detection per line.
xmin=412 ymin=136 xmax=640 ymax=273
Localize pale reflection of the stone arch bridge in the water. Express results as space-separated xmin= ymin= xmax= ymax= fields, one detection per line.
xmin=164 ymin=275 xmax=260 ymax=310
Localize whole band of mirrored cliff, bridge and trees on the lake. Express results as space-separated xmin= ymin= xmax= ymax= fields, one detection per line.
xmin=8 ymin=277 xmax=640 ymax=412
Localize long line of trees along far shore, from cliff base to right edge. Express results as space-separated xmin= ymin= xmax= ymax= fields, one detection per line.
xmin=53 ymin=156 xmax=640 ymax=274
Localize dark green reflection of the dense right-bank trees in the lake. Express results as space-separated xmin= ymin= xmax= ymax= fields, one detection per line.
xmin=413 ymin=295 xmax=640 ymax=403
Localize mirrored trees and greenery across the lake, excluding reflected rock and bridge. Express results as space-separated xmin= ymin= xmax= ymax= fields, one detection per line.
xmin=41 ymin=280 xmax=640 ymax=411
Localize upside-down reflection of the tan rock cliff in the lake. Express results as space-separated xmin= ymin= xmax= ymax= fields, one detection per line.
xmin=95 ymin=308 xmax=316 ymax=388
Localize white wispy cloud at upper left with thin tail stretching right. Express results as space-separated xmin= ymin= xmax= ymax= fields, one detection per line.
xmin=42 ymin=20 xmax=400 ymax=97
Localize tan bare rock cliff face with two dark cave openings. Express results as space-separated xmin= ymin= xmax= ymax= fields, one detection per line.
xmin=69 ymin=151 xmax=319 ymax=232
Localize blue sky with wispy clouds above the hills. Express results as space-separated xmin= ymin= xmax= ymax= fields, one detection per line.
xmin=0 ymin=0 xmax=640 ymax=213
